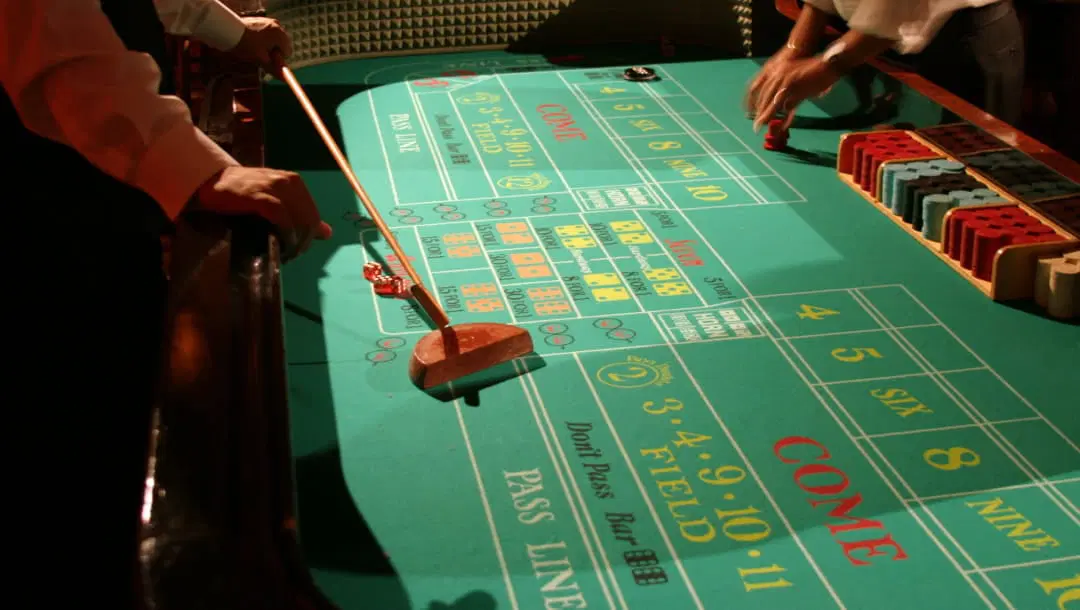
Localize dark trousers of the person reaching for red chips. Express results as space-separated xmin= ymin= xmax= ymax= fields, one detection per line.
xmin=899 ymin=0 xmax=1024 ymax=125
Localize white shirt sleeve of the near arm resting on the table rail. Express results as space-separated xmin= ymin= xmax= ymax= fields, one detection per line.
xmin=0 ymin=0 xmax=239 ymax=218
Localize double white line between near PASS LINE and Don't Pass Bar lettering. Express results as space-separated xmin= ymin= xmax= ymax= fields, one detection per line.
xmin=512 ymin=358 xmax=626 ymax=610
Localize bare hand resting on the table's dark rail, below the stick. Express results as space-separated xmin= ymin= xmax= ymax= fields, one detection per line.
xmin=192 ymin=167 xmax=332 ymax=260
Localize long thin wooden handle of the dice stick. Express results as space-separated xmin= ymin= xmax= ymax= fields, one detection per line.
xmin=274 ymin=52 xmax=450 ymax=328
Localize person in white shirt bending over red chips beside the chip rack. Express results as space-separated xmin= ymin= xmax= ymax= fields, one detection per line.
xmin=745 ymin=0 xmax=1024 ymax=131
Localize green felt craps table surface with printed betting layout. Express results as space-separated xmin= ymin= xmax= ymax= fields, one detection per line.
xmin=265 ymin=53 xmax=1080 ymax=610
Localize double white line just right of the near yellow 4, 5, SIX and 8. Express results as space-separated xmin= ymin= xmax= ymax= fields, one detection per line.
xmin=850 ymin=290 xmax=1080 ymax=525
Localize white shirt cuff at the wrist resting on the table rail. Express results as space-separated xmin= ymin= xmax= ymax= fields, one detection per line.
xmin=133 ymin=123 xmax=240 ymax=220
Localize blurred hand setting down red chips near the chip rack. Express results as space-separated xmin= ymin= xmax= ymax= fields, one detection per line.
xmin=748 ymin=57 xmax=839 ymax=132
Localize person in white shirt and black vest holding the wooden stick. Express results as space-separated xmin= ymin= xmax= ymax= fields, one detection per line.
xmin=0 ymin=0 xmax=330 ymax=609
